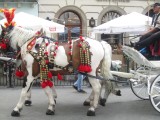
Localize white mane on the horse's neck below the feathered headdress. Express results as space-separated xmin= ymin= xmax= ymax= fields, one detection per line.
xmin=8 ymin=26 xmax=36 ymax=50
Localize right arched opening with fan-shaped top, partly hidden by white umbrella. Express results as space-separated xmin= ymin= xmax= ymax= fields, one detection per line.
xmin=101 ymin=11 xmax=123 ymax=50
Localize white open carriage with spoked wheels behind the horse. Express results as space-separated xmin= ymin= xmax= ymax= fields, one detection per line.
xmin=112 ymin=46 xmax=160 ymax=112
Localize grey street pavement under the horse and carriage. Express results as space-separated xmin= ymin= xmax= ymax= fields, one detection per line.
xmin=0 ymin=86 xmax=160 ymax=120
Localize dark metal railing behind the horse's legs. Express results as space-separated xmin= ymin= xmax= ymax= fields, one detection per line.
xmin=0 ymin=61 xmax=87 ymax=87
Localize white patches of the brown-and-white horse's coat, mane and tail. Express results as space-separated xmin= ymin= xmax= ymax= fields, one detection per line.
xmin=6 ymin=27 xmax=111 ymax=116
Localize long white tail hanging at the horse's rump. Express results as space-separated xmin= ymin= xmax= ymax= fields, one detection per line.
xmin=100 ymin=41 xmax=113 ymax=79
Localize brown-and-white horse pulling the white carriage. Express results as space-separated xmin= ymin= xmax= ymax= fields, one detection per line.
xmin=0 ymin=27 xmax=112 ymax=116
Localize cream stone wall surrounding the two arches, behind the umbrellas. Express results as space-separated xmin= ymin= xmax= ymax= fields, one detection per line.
xmin=38 ymin=0 xmax=154 ymax=35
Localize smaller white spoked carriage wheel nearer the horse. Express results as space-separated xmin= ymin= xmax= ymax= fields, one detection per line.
xmin=130 ymin=67 xmax=149 ymax=100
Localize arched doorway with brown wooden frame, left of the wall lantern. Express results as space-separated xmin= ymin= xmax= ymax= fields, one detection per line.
xmin=58 ymin=11 xmax=82 ymax=42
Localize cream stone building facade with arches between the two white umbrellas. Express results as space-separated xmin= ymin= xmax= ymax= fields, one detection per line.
xmin=38 ymin=0 xmax=158 ymax=39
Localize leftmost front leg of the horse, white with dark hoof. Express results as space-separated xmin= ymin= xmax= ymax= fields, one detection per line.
xmin=11 ymin=74 xmax=34 ymax=117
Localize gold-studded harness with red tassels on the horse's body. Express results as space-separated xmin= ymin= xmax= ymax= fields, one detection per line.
xmin=27 ymin=36 xmax=91 ymax=82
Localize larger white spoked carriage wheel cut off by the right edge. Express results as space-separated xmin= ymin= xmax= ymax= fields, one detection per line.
xmin=150 ymin=75 xmax=160 ymax=112
